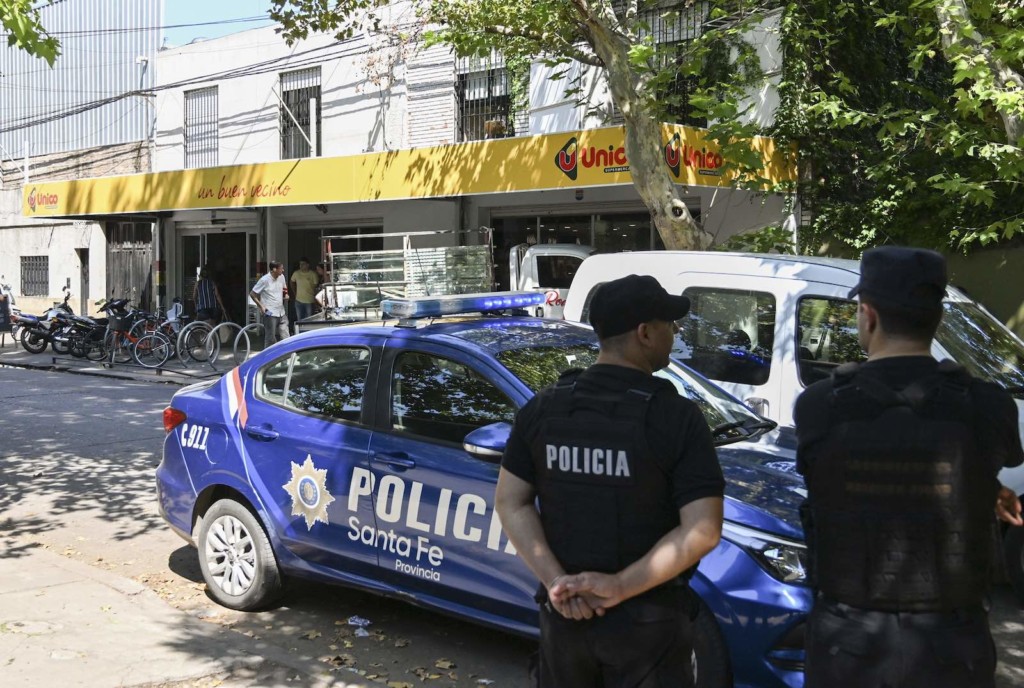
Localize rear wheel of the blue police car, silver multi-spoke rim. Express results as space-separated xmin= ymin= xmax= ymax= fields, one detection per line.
xmin=198 ymin=500 xmax=282 ymax=611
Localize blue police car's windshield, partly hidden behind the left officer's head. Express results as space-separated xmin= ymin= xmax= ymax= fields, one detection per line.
xmin=496 ymin=343 xmax=763 ymax=442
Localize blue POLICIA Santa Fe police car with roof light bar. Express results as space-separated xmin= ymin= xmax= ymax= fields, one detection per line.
xmin=157 ymin=293 xmax=811 ymax=688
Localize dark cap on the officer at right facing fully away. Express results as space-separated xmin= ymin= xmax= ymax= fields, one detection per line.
xmin=849 ymin=246 xmax=947 ymax=310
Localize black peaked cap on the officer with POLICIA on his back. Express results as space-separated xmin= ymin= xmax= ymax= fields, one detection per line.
xmin=590 ymin=274 xmax=690 ymax=339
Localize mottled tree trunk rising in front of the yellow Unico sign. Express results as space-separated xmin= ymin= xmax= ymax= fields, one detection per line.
xmin=573 ymin=0 xmax=712 ymax=251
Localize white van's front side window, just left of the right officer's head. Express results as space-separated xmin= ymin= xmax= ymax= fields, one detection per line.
xmin=797 ymin=297 xmax=866 ymax=386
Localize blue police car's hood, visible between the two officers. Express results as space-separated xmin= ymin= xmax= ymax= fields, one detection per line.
xmin=718 ymin=440 xmax=807 ymax=540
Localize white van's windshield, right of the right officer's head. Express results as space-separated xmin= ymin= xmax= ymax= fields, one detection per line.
xmin=935 ymin=301 xmax=1024 ymax=396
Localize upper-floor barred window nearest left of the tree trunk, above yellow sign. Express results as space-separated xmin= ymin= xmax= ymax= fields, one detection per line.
xmin=455 ymin=52 xmax=515 ymax=141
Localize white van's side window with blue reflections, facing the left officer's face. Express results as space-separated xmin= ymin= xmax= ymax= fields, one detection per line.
xmin=676 ymin=287 xmax=775 ymax=385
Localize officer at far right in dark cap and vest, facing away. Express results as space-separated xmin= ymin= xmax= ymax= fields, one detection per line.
xmin=794 ymin=247 xmax=1024 ymax=688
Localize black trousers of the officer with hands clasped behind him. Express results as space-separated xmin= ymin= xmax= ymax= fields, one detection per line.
xmin=539 ymin=588 xmax=693 ymax=688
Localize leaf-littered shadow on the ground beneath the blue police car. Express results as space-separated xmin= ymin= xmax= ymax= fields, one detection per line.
xmin=161 ymin=573 xmax=537 ymax=688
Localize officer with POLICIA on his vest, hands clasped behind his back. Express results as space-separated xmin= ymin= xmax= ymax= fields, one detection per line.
xmin=496 ymin=274 xmax=725 ymax=688
